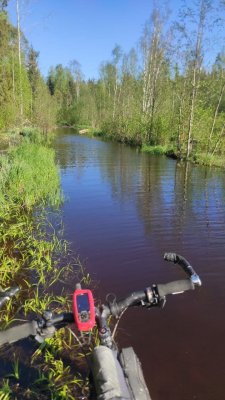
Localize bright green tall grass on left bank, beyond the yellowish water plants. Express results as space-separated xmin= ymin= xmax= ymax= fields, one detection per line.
xmin=0 ymin=143 xmax=61 ymax=209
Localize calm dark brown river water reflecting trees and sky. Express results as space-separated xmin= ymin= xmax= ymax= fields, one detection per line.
xmin=55 ymin=129 xmax=225 ymax=400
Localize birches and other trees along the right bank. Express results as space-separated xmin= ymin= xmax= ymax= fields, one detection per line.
xmin=47 ymin=0 xmax=225 ymax=158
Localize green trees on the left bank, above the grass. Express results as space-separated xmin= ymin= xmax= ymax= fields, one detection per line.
xmin=0 ymin=0 xmax=56 ymax=131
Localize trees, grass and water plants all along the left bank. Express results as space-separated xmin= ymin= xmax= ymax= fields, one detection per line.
xmin=0 ymin=4 xmax=89 ymax=400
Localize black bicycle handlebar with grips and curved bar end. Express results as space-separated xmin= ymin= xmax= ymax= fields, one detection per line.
xmin=0 ymin=253 xmax=201 ymax=346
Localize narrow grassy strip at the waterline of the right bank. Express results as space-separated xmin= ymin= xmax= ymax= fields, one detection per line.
xmin=73 ymin=126 xmax=225 ymax=168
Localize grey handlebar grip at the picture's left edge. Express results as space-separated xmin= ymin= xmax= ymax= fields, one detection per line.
xmin=0 ymin=321 xmax=38 ymax=346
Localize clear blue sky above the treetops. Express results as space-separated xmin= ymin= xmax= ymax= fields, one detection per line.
xmin=8 ymin=0 xmax=225 ymax=78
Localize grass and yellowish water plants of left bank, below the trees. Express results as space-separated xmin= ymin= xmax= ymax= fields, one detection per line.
xmin=0 ymin=131 xmax=87 ymax=400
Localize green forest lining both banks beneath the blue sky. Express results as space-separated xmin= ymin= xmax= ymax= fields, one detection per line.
xmin=0 ymin=0 xmax=225 ymax=165
